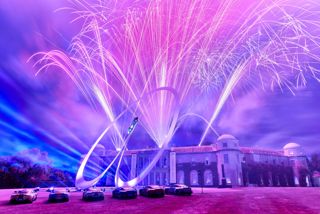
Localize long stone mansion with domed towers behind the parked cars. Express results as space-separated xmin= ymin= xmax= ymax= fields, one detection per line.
xmin=91 ymin=134 xmax=310 ymax=187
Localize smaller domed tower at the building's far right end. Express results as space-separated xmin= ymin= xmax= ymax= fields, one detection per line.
xmin=283 ymin=142 xmax=310 ymax=186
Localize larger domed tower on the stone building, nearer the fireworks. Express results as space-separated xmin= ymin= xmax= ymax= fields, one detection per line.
xmin=217 ymin=134 xmax=242 ymax=186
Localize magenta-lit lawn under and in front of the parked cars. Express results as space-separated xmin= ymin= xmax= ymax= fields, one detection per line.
xmin=0 ymin=187 xmax=320 ymax=214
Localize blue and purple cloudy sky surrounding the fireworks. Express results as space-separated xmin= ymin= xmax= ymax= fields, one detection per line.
xmin=0 ymin=0 xmax=320 ymax=171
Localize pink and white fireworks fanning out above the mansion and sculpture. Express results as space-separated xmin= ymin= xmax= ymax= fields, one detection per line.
xmin=31 ymin=0 xmax=320 ymax=185
